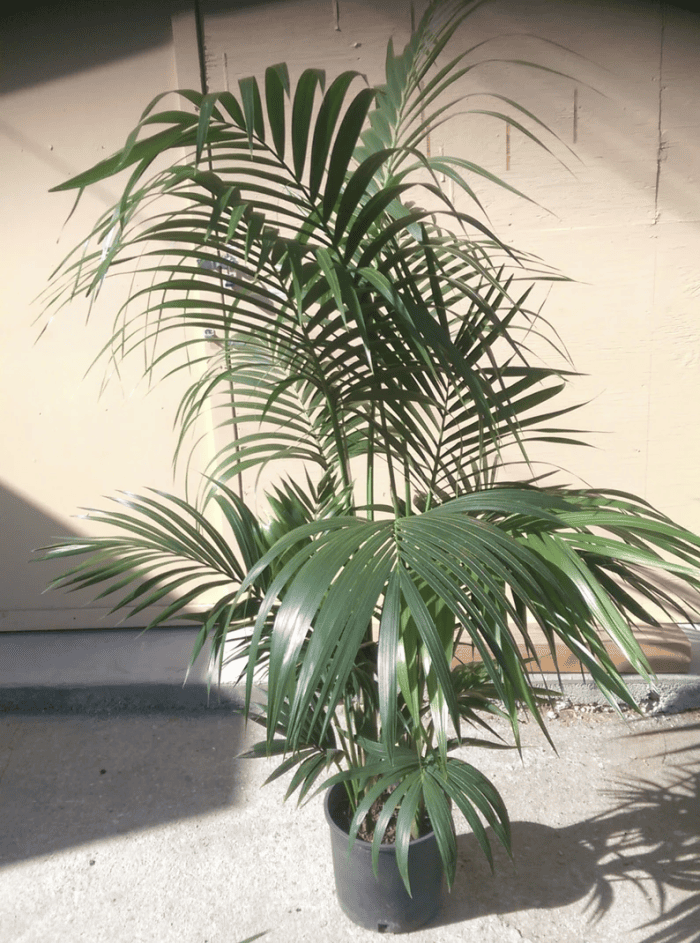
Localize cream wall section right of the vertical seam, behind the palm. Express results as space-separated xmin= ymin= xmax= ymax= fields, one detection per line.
xmin=198 ymin=0 xmax=700 ymax=530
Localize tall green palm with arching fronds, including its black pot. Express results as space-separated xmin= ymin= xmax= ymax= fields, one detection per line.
xmin=37 ymin=0 xmax=700 ymax=929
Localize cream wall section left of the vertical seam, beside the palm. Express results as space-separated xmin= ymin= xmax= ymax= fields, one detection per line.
xmin=0 ymin=0 xmax=191 ymax=631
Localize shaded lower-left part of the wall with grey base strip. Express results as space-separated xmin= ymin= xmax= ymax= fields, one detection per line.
xmin=0 ymin=486 xmax=216 ymax=684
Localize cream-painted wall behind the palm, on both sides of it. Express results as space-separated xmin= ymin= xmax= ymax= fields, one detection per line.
xmin=0 ymin=0 xmax=700 ymax=629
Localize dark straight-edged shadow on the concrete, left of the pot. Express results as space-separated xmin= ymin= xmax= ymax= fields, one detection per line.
xmin=0 ymin=709 xmax=243 ymax=867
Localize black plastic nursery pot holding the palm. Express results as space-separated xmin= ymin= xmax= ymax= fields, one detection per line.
xmin=325 ymin=783 xmax=443 ymax=933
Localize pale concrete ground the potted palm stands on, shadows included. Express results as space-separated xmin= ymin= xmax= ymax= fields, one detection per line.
xmin=0 ymin=689 xmax=700 ymax=943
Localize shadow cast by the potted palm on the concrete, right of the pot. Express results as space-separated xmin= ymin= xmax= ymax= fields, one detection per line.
xmin=436 ymin=761 xmax=700 ymax=943
